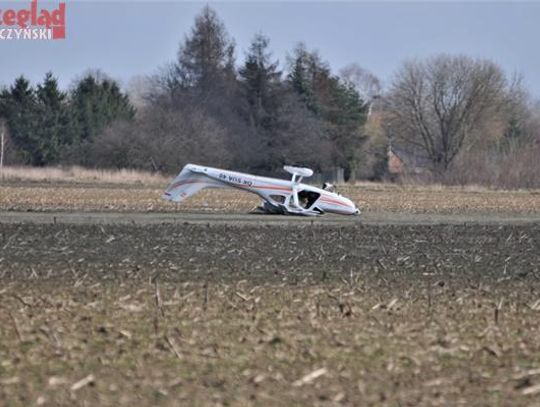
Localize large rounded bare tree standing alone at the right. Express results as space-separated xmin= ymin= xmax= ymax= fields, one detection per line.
xmin=387 ymin=55 xmax=506 ymax=172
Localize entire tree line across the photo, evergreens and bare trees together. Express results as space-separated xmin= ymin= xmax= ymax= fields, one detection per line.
xmin=0 ymin=6 xmax=540 ymax=184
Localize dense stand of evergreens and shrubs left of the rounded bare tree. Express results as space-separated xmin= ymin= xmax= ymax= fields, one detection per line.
xmin=0 ymin=7 xmax=368 ymax=180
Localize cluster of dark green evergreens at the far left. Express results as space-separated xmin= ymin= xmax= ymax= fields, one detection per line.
xmin=0 ymin=72 xmax=135 ymax=166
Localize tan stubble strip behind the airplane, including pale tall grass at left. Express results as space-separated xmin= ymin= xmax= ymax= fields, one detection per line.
xmin=0 ymin=167 xmax=540 ymax=214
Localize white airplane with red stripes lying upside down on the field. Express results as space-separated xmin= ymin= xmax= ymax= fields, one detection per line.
xmin=162 ymin=164 xmax=360 ymax=216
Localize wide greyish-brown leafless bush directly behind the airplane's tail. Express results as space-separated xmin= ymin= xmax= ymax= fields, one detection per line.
xmin=86 ymin=106 xmax=231 ymax=174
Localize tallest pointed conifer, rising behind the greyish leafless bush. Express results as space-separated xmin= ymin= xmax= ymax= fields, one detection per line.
xmin=155 ymin=6 xmax=245 ymax=172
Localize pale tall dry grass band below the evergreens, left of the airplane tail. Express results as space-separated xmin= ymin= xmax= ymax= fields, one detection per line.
xmin=0 ymin=166 xmax=166 ymax=185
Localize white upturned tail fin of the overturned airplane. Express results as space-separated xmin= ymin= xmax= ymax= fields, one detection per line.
xmin=161 ymin=164 xmax=223 ymax=202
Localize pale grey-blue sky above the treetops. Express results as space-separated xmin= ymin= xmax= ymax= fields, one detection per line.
xmin=0 ymin=0 xmax=540 ymax=98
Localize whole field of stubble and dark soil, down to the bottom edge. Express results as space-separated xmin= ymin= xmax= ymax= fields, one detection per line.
xmin=0 ymin=184 xmax=540 ymax=406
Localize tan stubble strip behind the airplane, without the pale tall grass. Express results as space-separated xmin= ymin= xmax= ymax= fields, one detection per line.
xmin=0 ymin=182 xmax=540 ymax=215
